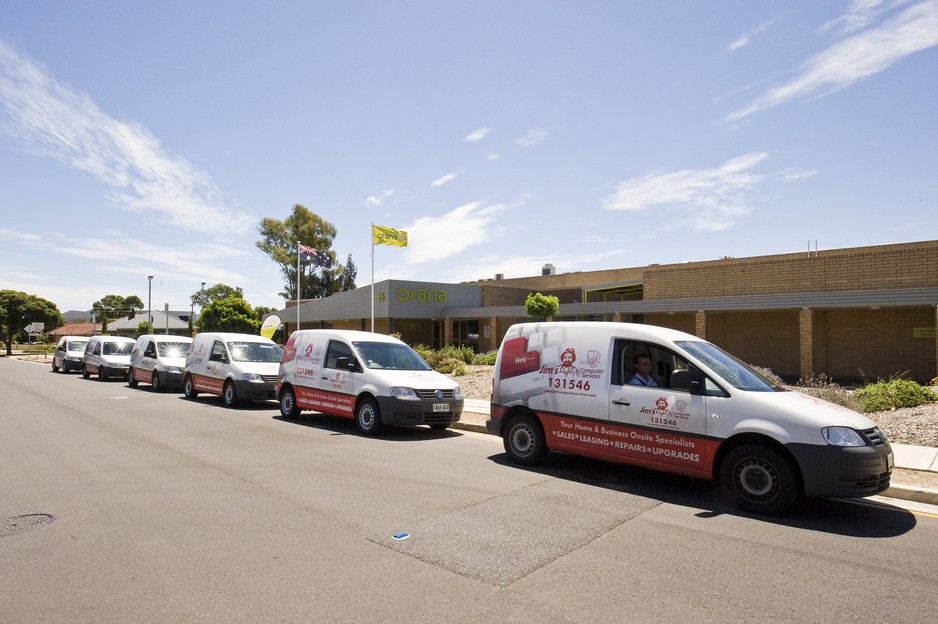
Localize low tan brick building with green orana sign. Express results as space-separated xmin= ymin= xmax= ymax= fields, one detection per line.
xmin=279 ymin=241 xmax=938 ymax=382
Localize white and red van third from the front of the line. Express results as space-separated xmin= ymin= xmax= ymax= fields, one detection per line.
xmin=182 ymin=332 xmax=283 ymax=407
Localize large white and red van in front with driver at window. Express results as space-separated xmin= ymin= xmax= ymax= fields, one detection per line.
xmin=486 ymin=322 xmax=893 ymax=513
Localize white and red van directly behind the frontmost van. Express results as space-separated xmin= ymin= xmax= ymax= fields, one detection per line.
xmin=277 ymin=329 xmax=463 ymax=435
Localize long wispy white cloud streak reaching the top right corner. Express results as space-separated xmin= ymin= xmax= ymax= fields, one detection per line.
xmin=724 ymin=0 xmax=938 ymax=121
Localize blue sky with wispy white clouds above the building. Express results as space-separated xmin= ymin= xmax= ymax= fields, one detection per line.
xmin=0 ymin=0 xmax=938 ymax=312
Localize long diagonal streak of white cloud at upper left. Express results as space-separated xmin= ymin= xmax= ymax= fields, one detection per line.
xmin=0 ymin=41 xmax=252 ymax=234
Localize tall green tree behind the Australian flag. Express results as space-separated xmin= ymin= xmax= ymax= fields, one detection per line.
xmin=257 ymin=204 xmax=357 ymax=299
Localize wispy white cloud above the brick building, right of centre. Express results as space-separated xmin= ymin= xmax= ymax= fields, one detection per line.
xmin=602 ymin=152 xmax=768 ymax=231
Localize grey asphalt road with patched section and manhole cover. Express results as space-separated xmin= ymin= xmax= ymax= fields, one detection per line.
xmin=0 ymin=359 xmax=938 ymax=624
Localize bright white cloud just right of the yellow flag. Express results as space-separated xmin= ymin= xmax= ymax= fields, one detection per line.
xmin=404 ymin=201 xmax=520 ymax=264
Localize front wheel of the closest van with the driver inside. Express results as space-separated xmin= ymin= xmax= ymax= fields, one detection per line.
xmin=720 ymin=444 xmax=801 ymax=515
